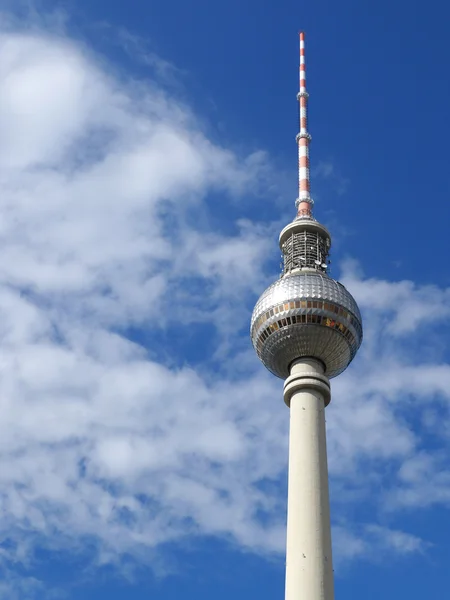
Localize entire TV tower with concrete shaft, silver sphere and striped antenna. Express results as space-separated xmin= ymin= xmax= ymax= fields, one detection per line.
xmin=250 ymin=33 xmax=363 ymax=600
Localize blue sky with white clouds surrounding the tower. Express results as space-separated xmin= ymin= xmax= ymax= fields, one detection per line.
xmin=0 ymin=0 xmax=450 ymax=600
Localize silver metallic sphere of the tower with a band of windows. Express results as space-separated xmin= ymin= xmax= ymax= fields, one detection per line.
xmin=250 ymin=272 xmax=362 ymax=379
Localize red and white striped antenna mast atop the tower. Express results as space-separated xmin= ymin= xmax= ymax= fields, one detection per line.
xmin=295 ymin=31 xmax=314 ymax=219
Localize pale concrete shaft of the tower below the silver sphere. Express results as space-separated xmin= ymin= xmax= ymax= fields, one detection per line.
xmin=284 ymin=358 xmax=334 ymax=600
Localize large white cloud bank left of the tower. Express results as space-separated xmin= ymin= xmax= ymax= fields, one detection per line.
xmin=0 ymin=18 xmax=284 ymax=576
